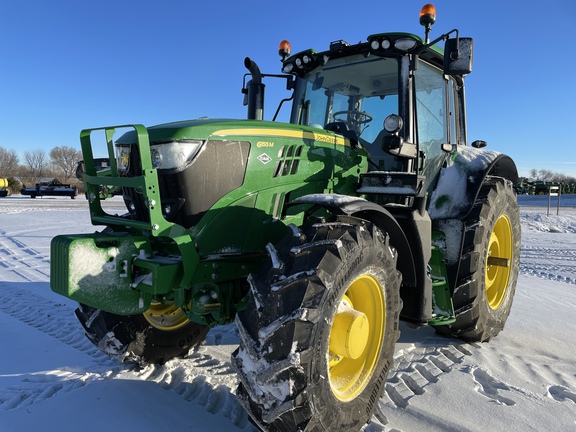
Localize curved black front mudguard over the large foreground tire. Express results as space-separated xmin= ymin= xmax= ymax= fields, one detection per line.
xmin=288 ymin=194 xmax=417 ymax=287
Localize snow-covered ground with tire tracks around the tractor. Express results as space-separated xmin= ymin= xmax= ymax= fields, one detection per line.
xmin=0 ymin=196 xmax=576 ymax=432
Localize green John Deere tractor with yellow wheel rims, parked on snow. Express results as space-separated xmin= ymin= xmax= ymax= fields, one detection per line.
xmin=51 ymin=5 xmax=520 ymax=431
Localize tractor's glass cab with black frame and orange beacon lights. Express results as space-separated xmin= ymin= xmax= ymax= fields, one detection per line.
xmin=245 ymin=5 xmax=472 ymax=201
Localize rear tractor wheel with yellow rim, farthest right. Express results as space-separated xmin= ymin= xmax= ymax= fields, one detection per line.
xmin=436 ymin=177 xmax=520 ymax=342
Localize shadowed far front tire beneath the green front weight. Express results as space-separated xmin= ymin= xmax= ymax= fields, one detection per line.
xmin=76 ymin=304 xmax=209 ymax=364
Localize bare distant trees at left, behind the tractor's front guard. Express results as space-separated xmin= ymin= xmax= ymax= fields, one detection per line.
xmin=0 ymin=146 xmax=82 ymax=192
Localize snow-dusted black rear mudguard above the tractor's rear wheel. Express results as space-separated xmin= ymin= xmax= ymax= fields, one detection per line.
xmin=428 ymin=146 xmax=518 ymax=220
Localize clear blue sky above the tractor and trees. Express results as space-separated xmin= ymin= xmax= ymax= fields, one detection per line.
xmin=0 ymin=0 xmax=576 ymax=177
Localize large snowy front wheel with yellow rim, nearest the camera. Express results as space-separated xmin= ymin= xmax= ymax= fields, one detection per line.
xmin=232 ymin=217 xmax=402 ymax=431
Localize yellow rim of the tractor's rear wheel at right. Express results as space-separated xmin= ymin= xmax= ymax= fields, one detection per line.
xmin=485 ymin=215 xmax=513 ymax=310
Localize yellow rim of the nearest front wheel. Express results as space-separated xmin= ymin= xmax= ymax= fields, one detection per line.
xmin=328 ymin=274 xmax=386 ymax=402
